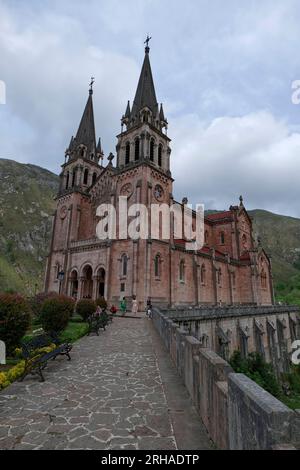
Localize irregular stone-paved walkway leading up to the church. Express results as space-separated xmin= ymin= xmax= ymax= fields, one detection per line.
xmin=0 ymin=318 xmax=210 ymax=450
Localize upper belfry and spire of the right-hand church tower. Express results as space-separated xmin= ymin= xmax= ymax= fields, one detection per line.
xmin=116 ymin=38 xmax=171 ymax=176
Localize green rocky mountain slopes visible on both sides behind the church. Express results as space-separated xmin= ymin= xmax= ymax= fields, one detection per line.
xmin=0 ymin=159 xmax=300 ymax=299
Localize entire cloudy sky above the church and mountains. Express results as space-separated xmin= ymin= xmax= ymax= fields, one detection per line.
xmin=0 ymin=0 xmax=300 ymax=217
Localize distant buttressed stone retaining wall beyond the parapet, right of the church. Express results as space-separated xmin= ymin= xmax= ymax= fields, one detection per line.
xmin=161 ymin=306 xmax=300 ymax=374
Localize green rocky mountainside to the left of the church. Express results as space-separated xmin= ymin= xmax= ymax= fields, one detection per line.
xmin=0 ymin=159 xmax=59 ymax=295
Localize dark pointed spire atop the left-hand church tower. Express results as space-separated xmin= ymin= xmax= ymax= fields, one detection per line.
xmin=75 ymin=84 xmax=96 ymax=157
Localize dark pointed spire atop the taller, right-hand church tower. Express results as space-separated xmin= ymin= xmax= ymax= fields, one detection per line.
xmin=131 ymin=44 xmax=158 ymax=116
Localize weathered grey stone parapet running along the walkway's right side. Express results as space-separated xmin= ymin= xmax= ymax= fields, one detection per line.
xmin=153 ymin=309 xmax=300 ymax=450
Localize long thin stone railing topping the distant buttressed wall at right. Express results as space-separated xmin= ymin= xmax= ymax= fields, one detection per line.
xmin=161 ymin=305 xmax=300 ymax=321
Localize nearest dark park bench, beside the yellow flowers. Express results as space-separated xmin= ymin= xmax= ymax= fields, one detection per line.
xmin=20 ymin=332 xmax=72 ymax=382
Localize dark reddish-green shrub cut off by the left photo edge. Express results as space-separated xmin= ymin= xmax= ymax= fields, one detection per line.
xmin=0 ymin=294 xmax=31 ymax=354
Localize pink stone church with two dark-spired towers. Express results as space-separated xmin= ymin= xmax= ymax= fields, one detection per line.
xmin=45 ymin=45 xmax=274 ymax=309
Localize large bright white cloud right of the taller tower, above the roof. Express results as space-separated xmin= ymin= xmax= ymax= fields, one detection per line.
xmin=172 ymin=111 xmax=300 ymax=216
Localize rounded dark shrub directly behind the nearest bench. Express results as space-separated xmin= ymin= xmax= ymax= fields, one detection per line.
xmin=40 ymin=295 xmax=75 ymax=332
